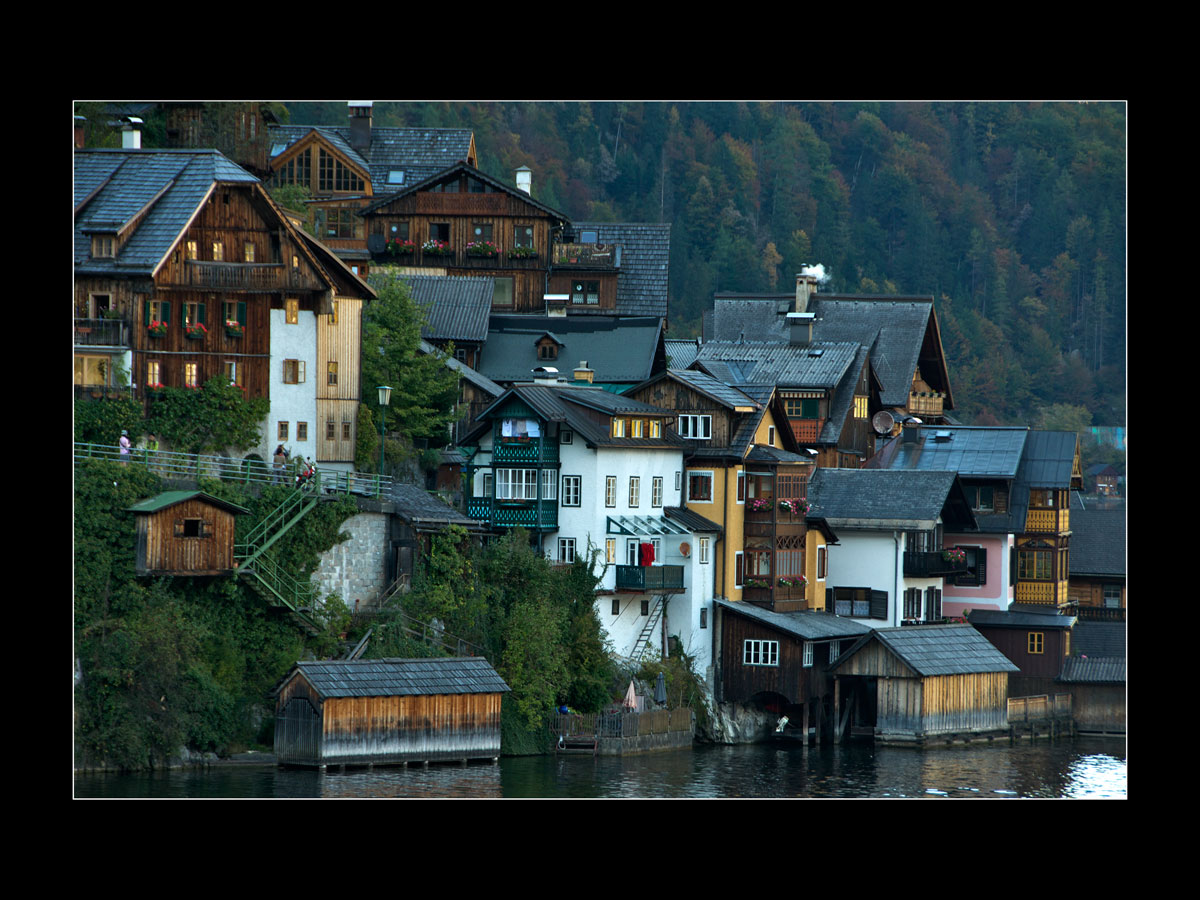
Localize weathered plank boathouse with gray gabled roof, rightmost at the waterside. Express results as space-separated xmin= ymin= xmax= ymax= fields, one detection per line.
xmin=832 ymin=625 xmax=1020 ymax=743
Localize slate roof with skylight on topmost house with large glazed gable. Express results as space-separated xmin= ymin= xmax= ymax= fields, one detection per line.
xmin=268 ymin=125 xmax=473 ymax=197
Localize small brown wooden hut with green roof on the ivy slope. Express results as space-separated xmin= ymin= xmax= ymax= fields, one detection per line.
xmin=128 ymin=491 xmax=250 ymax=575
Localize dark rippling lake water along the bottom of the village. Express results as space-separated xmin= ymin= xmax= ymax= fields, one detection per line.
xmin=74 ymin=738 xmax=1126 ymax=799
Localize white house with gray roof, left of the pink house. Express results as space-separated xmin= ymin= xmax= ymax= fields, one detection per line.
xmin=809 ymin=468 xmax=974 ymax=628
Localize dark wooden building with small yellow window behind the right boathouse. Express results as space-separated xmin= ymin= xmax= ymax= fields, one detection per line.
xmin=967 ymin=606 xmax=1075 ymax=697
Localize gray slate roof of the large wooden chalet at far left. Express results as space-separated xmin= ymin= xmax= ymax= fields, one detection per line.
xmin=74 ymin=150 xmax=258 ymax=276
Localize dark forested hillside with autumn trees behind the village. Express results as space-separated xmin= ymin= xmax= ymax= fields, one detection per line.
xmin=288 ymin=102 xmax=1126 ymax=427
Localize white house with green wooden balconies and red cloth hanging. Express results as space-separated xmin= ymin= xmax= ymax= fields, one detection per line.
xmin=463 ymin=377 xmax=720 ymax=667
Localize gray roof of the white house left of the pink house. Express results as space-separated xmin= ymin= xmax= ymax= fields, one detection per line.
xmin=809 ymin=468 xmax=974 ymax=530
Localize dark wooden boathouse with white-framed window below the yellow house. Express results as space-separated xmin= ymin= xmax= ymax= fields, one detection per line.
xmin=713 ymin=600 xmax=870 ymax=740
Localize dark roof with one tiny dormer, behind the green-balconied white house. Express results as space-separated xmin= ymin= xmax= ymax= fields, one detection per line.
xmin=479 ymin=316 xmax=662 ymax=384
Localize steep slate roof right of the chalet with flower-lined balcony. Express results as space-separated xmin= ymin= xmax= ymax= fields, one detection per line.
xmin=571 ymin=222 xmax=671 ymax=318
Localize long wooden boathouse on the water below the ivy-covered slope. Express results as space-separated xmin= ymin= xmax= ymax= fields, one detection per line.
xmin=275 ymin=656 xmax=510 ymax=767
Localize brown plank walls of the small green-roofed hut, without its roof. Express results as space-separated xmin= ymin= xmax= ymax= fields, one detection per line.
xmin=137 ymin=498 xmax=235 ymax=575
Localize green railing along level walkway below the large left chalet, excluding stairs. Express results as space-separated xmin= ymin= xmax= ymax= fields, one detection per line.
xmin=74 ymin=442 xmax=392 ymax=497
